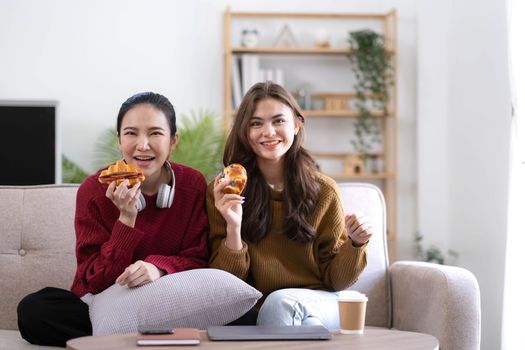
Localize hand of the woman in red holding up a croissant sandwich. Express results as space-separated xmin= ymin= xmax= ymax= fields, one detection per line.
xmin=106 ymin=180 xmax=140 ymax=227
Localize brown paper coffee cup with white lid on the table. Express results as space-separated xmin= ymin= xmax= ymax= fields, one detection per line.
xmin=339 ymin=290 xmax=368 ymax=334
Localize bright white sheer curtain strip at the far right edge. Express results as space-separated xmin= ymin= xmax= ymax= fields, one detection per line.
xmin=501 ymin=0 xmax=525 ymax=350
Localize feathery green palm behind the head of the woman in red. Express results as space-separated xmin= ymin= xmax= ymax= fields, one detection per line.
xmin=95 ymin=110 xmax=225 ymax=180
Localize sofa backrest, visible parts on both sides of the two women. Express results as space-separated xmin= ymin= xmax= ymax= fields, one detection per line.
xmin=0 ymin=183 xmax=390 ymax=329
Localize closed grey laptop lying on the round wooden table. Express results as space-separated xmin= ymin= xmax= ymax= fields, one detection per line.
xmin=208 ymin=326 xmax=332 ymax=341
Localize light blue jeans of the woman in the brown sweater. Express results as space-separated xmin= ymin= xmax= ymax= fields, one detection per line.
xmin=257 ymin=288 xmax=339 ymax=329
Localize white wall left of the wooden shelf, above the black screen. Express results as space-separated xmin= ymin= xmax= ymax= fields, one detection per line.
xmin=0 ymin=0 xmax=223 ymax=171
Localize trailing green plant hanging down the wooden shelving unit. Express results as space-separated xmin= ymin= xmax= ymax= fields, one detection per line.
xmin=348 ymin=30 xmax=394 ymax=153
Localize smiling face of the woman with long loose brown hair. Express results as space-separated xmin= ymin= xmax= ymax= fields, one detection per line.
xmin=248 ymin=98 xmax=299 ymax=162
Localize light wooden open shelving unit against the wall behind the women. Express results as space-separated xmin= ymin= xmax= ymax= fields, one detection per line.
xmin=223 ymin=9 xmax=397 ymax=261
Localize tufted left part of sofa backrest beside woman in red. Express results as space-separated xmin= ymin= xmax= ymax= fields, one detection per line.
xmin=0 ymin=185 xmax=78 ymax=329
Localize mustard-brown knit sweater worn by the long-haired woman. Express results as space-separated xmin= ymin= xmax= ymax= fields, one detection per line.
xmin=206 ymin=174 xmax=367 ymax=296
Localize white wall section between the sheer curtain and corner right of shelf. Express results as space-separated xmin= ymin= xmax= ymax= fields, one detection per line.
xmin=417 ymin=0 xmax=510 ymax=349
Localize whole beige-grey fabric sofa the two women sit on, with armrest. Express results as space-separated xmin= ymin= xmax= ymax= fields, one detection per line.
xmin=0 ymin=183 xmax=481 ymax=350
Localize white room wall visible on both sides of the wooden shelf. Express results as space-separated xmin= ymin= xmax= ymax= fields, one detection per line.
xmin=0 ymin=0 xmax=509 ymax=349
